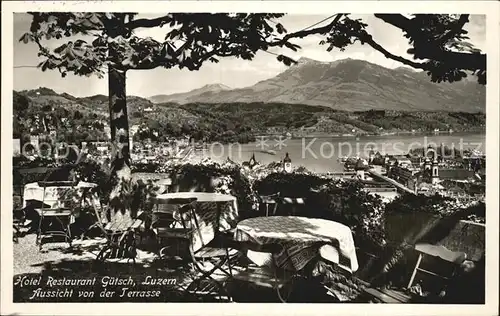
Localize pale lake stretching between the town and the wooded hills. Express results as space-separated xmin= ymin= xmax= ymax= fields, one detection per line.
xmin=194 ymin=134 xmax=486 ymax=172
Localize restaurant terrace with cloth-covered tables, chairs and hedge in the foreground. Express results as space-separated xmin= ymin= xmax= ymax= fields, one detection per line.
xmin=10 ymin=158 xmax=484 ymax=302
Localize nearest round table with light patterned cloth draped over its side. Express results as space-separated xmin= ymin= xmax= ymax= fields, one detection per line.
xmin=234 ymin=216 xmax=358 ymax=273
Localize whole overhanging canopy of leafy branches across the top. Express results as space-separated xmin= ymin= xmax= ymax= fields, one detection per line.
xmin=20 ymin=12 xmax=486 ymax=84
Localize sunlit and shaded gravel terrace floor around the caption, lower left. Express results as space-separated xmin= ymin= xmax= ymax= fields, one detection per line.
xmin=13 ymin=230 xmax=342 ymax=302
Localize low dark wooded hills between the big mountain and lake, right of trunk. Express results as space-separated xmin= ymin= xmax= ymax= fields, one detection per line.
xmin=175 ymin=102 xmax=486 ymax=136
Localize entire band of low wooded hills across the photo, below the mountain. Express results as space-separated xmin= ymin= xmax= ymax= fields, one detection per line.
xmin=13 ymin=88 xmax=486 ymax=143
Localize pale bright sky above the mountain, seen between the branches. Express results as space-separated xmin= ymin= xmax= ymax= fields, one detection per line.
xmin=13 ymin=13 xmax=486 ymax=97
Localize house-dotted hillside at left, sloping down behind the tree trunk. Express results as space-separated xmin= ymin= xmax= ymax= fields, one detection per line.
xmin=13 ymin=87 xmax=197 ymax=141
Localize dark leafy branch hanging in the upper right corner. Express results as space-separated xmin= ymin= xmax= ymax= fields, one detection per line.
xmin=311 ymin=14 xmax=486 ymax=84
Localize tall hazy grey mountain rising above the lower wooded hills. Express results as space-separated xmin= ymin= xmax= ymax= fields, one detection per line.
xmin=149 ymin=58 xmax=486 ymax=112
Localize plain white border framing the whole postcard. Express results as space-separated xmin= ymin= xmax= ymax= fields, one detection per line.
xmin=0 ymin=1 xmax=500 ymax=316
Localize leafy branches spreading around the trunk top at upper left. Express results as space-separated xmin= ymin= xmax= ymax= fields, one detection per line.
xmin=20 ymin=12 xmax=304 ymax=76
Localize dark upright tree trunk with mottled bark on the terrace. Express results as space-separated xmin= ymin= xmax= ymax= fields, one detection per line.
xmin=108 ymin=66 xmax=133 ymax=224
